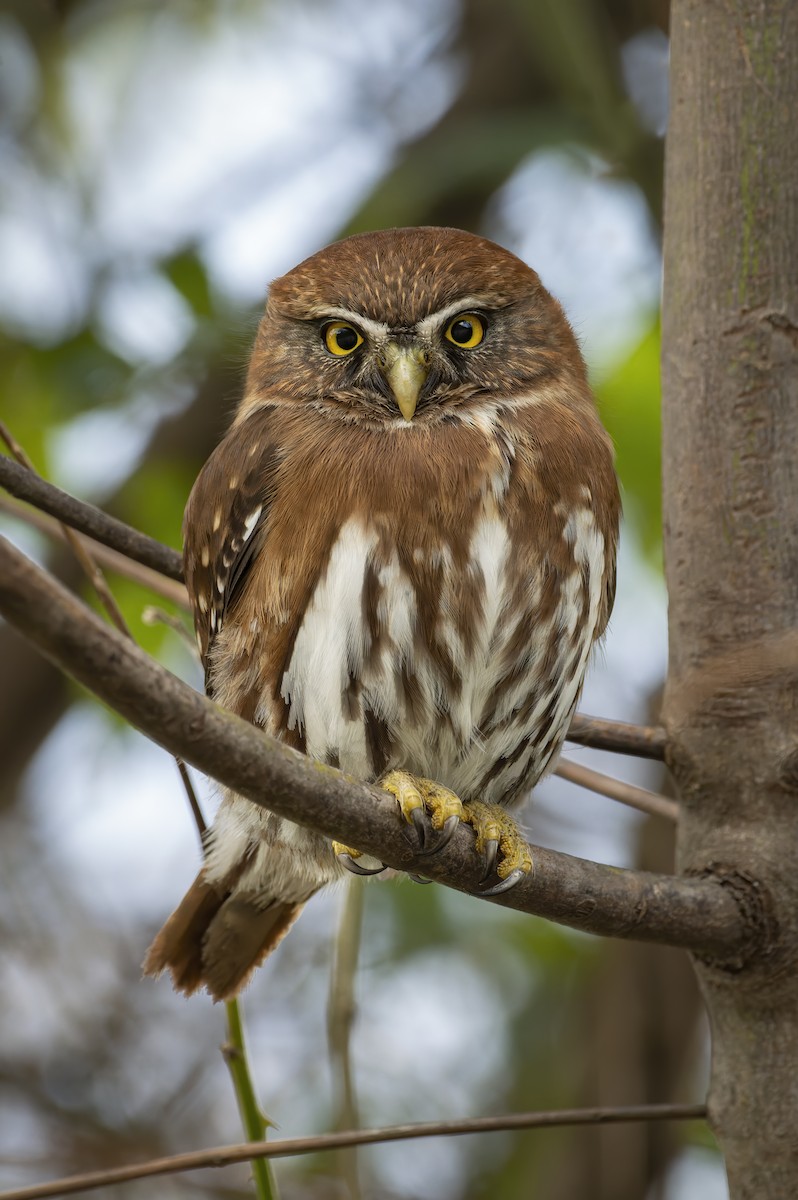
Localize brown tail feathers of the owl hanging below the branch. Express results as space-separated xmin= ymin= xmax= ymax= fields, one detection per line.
xmin=143 ymin=871 xmax=306 ymax=1000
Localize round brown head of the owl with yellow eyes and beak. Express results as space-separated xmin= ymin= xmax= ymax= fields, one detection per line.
xmin=239 ymin=227 xmax=586 ymax=426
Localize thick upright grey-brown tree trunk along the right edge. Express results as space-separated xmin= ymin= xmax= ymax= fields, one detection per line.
xmin=662 ymin=0 xmax=798 ymax=1200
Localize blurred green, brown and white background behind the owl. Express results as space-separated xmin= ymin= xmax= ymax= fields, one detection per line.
xmin=0 ymin=0 xmax=727 ymax=1200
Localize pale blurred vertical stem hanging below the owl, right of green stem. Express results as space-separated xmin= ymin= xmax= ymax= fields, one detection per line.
xmin=328 ymin=878 xmax=364 ymax=1200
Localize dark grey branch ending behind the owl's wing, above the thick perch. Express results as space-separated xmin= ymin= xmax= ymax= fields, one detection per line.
xmin=0 ymin=455 xmax=182 ymax=581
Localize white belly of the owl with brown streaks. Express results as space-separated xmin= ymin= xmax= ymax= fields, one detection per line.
xmin=280 ymin=487 xmax=604 ymax=802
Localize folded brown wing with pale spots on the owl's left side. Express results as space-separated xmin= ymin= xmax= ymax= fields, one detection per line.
xmin=182 ymin=413 xmax=281 ymax=670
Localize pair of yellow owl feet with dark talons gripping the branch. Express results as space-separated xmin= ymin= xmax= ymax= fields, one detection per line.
xmin=380 ymin=770 xmax=532 ymax=896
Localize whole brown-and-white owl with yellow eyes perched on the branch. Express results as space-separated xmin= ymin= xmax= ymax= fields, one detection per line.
xmin=145 ymin=228 xmax=619 ymax=1000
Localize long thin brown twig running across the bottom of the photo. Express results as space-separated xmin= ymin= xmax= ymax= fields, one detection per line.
xmin=0 ymin=1104 xmax=707 ymax=1200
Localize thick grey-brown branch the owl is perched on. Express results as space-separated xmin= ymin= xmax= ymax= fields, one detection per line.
xmin=0 ymin=539 xmax=760 ymax=962
